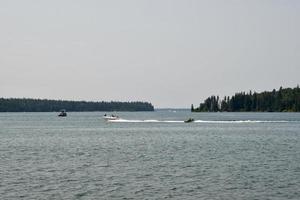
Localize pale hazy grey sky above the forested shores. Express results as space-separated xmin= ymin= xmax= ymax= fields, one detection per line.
xmin=0 ymin=0 xmax=300 ymax=108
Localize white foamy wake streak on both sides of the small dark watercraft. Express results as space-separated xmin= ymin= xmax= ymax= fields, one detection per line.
xmin=108 ymin=118 xmax=290 ymax=124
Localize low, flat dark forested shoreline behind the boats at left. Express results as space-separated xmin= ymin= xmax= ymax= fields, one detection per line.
xmin=0 ymin=98 xmax=154 ymax=112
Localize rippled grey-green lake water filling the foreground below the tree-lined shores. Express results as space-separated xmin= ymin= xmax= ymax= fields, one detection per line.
xmin=0 ymin=110 xmax=300 ymax=200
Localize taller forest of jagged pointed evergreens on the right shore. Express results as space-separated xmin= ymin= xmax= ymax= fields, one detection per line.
xmin=191 ymin=85 xmax=300 ymax=112
